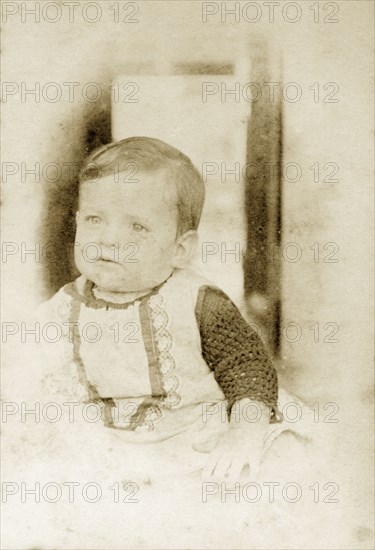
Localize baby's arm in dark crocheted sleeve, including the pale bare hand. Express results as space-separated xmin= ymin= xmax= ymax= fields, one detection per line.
xmin=196 ymin=287 xmax=278 ymax=478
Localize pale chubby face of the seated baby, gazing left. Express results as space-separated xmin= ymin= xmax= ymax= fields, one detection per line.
xmin=75 ymin=170 xmax=182 ymax=292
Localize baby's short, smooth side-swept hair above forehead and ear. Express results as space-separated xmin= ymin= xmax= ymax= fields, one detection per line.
xmin=79 ymin=136 xmax=205 ymax=235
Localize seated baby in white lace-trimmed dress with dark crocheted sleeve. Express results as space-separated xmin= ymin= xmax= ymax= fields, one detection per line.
xmin=36 ymin=137 xmax=288 ymax=479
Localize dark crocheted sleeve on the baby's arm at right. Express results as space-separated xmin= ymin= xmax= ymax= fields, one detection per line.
xmin=195 ymin=286 xmax=278 ymax=422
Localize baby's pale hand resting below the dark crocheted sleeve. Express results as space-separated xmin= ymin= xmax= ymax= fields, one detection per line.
xmin=202 ymin=428 xmax=262 ymax=481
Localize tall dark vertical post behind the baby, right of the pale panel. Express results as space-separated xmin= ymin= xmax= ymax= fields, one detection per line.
xmin=244 ymin=43 xmax=282 ymax=355
